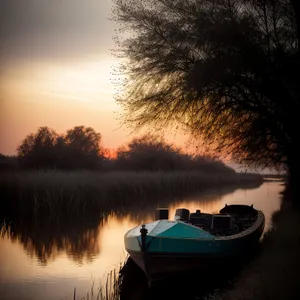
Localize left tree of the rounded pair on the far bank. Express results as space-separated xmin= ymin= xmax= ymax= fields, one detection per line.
xmin=17 ymin=127 xmax=58 ymax=169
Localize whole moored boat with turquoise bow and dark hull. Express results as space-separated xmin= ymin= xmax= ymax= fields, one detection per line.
xmin=124 ymin=204 xmax=265 ymax=283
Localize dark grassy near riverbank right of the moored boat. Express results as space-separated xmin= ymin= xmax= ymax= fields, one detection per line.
xmin=206 ymin=188 xmax=300 ymax=300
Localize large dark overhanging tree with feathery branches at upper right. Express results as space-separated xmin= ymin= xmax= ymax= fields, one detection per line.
xmin=113 ymin=0 xmax=300 ymax=202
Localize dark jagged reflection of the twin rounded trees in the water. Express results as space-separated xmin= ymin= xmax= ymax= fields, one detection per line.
xmin=2 ymin=218 xmax=102 ymax=267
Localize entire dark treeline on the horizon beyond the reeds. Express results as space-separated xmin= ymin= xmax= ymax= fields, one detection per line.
xmin=0 ymin=126 xmax=235 ymax=173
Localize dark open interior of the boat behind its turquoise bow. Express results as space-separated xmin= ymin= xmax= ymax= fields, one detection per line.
xmin=174 ymin=204 xmax=258 ymax=236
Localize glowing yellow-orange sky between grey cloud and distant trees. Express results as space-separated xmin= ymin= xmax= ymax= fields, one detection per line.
xmin=0 ymin=56 xmax=190 ymax=156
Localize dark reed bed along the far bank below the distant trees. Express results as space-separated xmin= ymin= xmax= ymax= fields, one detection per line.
xmin=0 ymin=171 xmax=262 ymax=219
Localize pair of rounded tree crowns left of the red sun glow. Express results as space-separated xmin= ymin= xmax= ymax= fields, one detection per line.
xmin=17 ymin=126 xmax=102 ymax=169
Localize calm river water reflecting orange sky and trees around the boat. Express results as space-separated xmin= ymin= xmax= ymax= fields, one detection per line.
xmin=0 ymin=182 xmax=284 ymax=300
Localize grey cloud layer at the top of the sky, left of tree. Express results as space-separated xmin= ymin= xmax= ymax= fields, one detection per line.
xmin=0 ymin=0 xmax=114 ymax=64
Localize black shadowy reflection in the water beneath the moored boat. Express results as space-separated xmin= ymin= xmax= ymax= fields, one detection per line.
xmin=119 ymin=251 xmax=260 ymax=300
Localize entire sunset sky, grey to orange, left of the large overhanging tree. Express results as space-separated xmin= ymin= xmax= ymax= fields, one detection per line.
xmin=0 ymin=0 xmax=190 ymax=155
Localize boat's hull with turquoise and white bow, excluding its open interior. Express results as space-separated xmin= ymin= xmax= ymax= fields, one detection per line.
xmin=124 ymin=211 xmax=265 ymax=281
